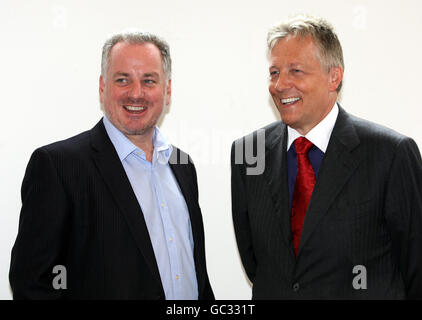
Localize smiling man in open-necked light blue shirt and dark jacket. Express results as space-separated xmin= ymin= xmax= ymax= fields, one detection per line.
xmin=10 ymin=32 xmax=214 ymax=300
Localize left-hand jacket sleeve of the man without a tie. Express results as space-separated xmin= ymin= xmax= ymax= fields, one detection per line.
xmin=9 ymin=149 xmax=68 ymax=299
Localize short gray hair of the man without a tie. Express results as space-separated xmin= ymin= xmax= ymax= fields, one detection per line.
xmin=101 ymin=30 xmax=171 ymax=80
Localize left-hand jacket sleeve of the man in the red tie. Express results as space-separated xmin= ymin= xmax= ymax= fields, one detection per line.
xmin=231 ymin=143 xmax=256 ymax=282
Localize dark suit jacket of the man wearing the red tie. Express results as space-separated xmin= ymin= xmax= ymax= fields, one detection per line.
xmin=232 ymin=108 xmax=422 ymax=299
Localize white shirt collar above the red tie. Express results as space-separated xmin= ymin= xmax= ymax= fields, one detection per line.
xmin=287 ymin=102 xmax=339 ymax=153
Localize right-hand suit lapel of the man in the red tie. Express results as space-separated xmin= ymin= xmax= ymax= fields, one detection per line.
xmin=298 ymin=107 xmax=359 ymax=255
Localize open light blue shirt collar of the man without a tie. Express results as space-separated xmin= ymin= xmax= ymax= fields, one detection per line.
xmin=103 ymin=115 xmax=173 ymax=164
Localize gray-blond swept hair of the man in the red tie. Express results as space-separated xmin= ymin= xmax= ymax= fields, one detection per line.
xmin=267 ymin=15 xmax=344 ymax=92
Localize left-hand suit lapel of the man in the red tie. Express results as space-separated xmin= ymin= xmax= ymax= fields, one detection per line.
xmin=264 ymin=122 xmax=295 ymax=258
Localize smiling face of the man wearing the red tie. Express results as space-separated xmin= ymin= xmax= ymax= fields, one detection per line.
xmin=269 ymin=35 xmax=343 ymax=135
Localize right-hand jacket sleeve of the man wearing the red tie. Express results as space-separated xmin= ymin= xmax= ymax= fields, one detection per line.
xmin=385 ymin=138 xmax=422 ymax=299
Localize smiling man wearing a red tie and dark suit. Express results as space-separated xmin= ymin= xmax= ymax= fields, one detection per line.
xmin=232 ymin=16 xmax=422 ymax=299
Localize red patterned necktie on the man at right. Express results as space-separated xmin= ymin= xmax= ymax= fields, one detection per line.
xmin=290 ymin=137 xmax=315 ymax=256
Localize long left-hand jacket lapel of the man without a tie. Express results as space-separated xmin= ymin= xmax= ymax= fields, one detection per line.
xmin=90 ymin=120 xmax=161 ymax=285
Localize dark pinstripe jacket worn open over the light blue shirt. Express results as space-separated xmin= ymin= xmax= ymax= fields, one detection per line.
xmin=9 ymin=120 xmax=214 ymax=299
